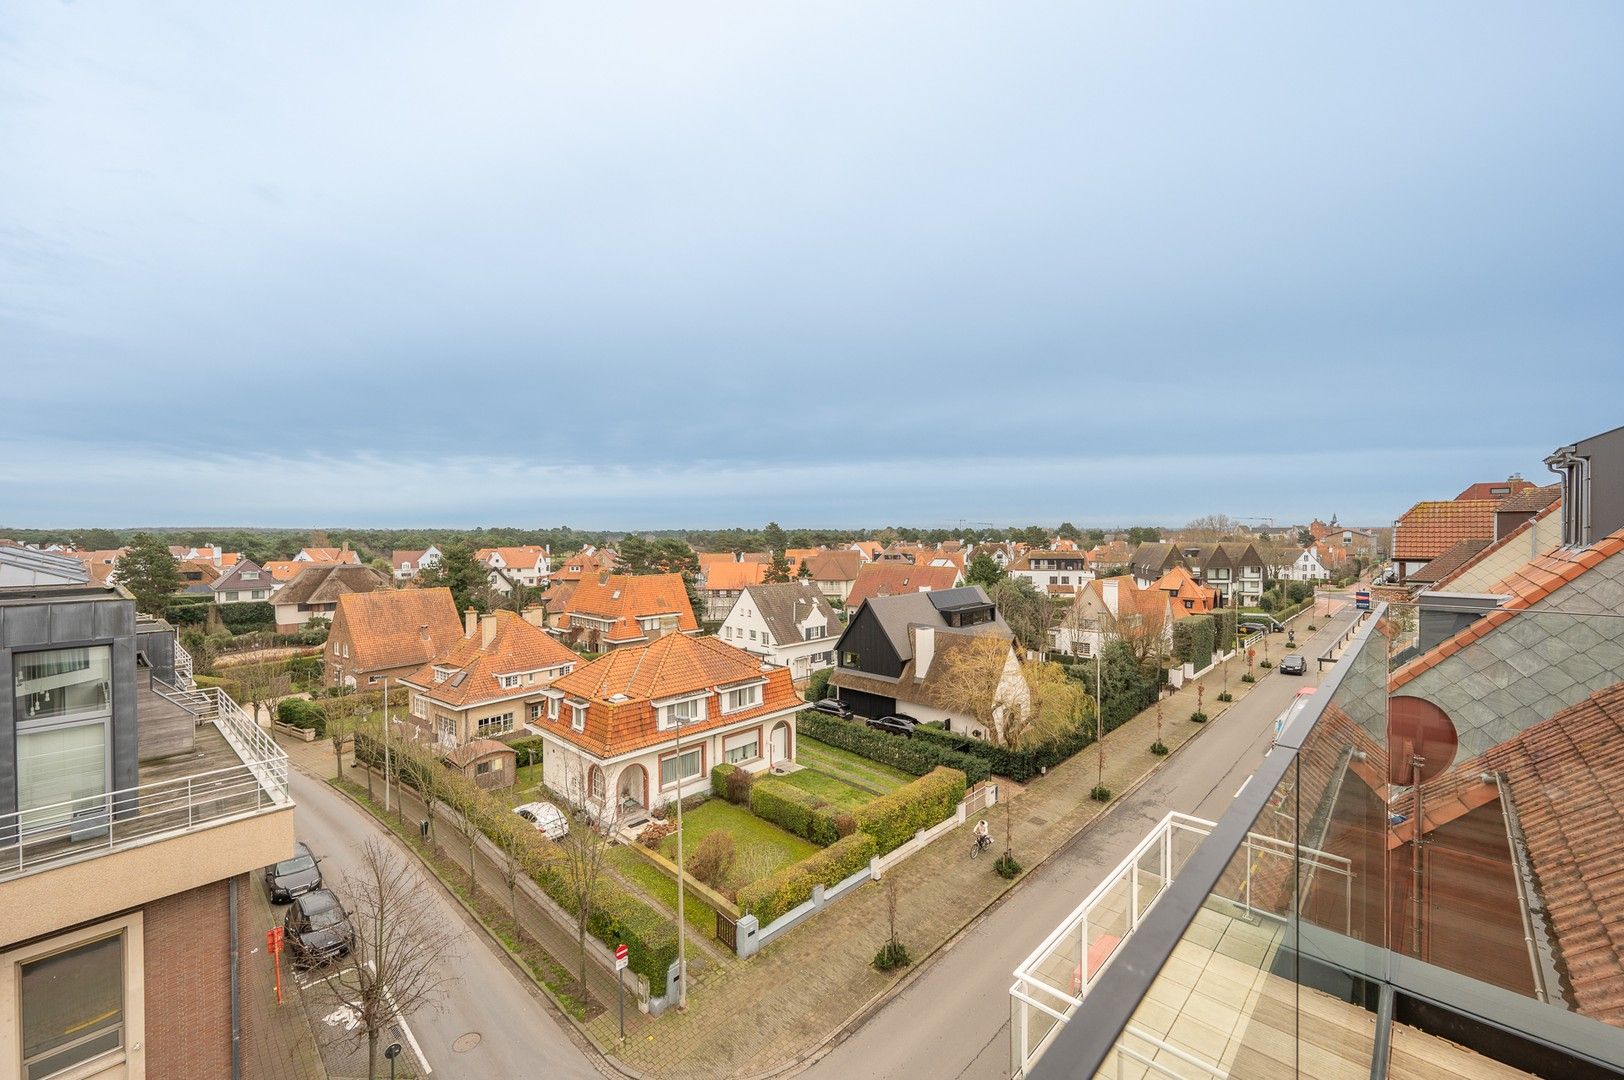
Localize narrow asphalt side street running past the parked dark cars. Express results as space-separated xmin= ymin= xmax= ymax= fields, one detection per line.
xmin=289 ymin=770 xmax=601 ymax=1080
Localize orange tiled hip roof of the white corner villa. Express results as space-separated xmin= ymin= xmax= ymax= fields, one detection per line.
xmin=544 ymin=633 xmax=804 ymax=753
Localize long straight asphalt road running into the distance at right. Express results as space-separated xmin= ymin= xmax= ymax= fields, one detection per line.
xmin=807 ymin=604 xmax=1358 ymax=1080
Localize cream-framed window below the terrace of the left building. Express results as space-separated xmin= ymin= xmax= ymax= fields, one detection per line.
xmin=18 ymin=934 xmax=125 ymax=1080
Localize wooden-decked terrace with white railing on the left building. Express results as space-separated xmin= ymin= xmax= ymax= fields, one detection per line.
xmin=0 ymin=682 xmax=292 ymax=940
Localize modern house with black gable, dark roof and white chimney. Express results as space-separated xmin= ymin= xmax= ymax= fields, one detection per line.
xmin=828 ymin=585 xmax=1030 ymax=739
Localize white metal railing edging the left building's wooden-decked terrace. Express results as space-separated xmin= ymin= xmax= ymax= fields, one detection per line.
xmin=0 ymin=690 xmax=289 ymax=877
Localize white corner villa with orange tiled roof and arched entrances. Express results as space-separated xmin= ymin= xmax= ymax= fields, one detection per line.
xmin=536 ymin=633 xmax=804 ymax=823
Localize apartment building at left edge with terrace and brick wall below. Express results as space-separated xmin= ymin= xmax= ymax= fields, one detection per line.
xmin=0 ymin=581 xmax=294 ymax=1080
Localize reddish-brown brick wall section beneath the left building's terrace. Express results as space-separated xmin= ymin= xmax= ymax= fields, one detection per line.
xmin=141 ymin=874 xmax=254 ymax=1080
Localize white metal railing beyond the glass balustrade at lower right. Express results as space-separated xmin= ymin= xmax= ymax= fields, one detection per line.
xmin=1010 ymin=812 xmax=1353 ymax=1077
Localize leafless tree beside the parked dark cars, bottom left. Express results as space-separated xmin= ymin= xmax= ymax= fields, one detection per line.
xmin=326 ymin=838 xmax=456 ymax=1080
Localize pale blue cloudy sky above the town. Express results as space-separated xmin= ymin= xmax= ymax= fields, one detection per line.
xmin=0 ymin=0 xmax=1624 ymax=529
